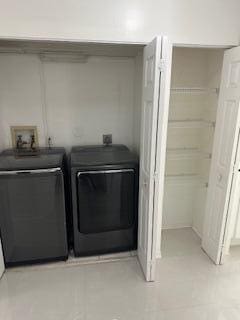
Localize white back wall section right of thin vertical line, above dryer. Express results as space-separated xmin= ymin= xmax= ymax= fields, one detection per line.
xmin=44 ymin=57 xmax=134 ymax=147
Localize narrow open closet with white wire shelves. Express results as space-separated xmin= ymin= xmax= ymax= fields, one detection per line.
xmin=159 ymin=47 xmax=224 ymax=258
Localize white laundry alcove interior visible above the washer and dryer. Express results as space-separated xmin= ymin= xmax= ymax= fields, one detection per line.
xmin=0 ymin=40 xmax=144 ymax=154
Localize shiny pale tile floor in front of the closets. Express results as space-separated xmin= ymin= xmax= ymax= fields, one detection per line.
xmin=0 ymin=229 xmax=240 ymax=320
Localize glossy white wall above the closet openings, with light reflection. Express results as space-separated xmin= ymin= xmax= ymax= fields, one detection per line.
xmin=0 ymin=0 xmax=240 ymax=45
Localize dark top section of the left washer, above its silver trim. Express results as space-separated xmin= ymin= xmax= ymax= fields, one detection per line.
xmin=0 ymin=148 xmax=65 ymax=171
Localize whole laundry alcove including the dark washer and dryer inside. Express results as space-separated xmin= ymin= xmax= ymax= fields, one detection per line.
xmin=0 ymin=41 xmax=148 ymax=267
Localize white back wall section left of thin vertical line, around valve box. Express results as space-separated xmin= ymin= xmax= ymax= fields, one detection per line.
xmin=0 ymin=54 xmax=45 ymax=147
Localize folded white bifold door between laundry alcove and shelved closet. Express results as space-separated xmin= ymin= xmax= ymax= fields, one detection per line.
xmin=138 ymin=37 xmax=171 ymax=281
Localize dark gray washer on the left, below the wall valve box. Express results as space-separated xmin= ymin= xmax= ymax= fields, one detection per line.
xmin=0 ymin=148 xmax=68 ymax=266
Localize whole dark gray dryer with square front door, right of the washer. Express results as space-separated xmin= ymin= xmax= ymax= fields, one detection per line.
xmin=70 ymin=145 xmax=138 ymax=256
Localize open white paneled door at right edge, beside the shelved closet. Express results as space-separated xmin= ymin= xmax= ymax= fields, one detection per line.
xmin=202 ymin=47 xmax=240 ymax=264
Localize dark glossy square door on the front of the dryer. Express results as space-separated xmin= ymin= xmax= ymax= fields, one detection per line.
xmin=77 ymin=169 xmax=136 ymax=234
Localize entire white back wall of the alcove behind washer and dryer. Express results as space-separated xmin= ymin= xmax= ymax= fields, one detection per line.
xmin=0 ymin=54 xmax=139 ymax=148
